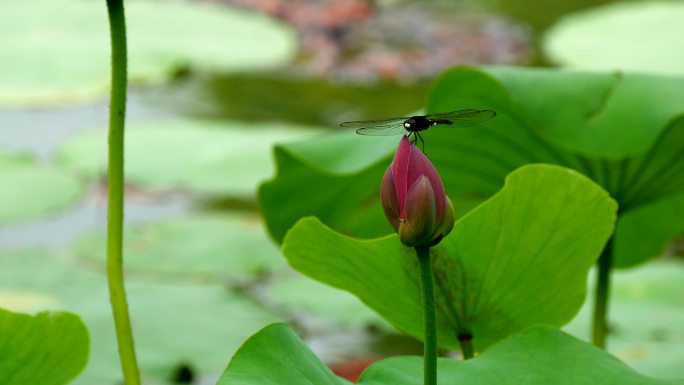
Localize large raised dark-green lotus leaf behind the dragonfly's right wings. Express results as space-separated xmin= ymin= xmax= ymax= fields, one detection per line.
xmin=423 ymin=68 xmax=684 ymax=202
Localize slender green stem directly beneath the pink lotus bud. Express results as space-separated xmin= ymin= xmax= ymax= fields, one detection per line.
xmin=416 ymin=246 xmax=437 ymax=385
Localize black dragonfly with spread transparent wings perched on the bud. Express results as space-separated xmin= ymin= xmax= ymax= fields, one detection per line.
xmin=340 ymin=109 xmax=496 ymax=147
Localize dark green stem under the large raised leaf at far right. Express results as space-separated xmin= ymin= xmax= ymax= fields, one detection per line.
xmin=591 ymin=237 xmax=613 ymax=349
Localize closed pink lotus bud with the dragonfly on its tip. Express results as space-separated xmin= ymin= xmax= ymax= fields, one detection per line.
xmin=381 ymin=136 xmax=455 ymax=247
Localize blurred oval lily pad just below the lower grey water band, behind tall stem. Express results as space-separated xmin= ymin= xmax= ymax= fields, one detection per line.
xmin=73 ymin=214 xmax=286 ymax=280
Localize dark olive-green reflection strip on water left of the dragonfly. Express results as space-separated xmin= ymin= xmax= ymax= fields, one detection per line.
xmin=145 ymin=72 xmax=430 ymax=126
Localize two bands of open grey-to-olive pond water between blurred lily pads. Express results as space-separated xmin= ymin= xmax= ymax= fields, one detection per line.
xmin=0 ymin=73 xmax=427 ymax=246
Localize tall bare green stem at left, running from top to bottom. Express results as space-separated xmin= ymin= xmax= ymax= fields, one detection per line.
xmin=107 ymin=0 xmax=140 ymax=385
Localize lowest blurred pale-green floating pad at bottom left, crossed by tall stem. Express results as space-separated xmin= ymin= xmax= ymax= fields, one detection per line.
xmin=0 ymin=250 xmax=279 ymax=385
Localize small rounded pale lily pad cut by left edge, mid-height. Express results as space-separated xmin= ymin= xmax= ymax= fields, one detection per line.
xmin=0 ymin=153 xmax=83 ymax=225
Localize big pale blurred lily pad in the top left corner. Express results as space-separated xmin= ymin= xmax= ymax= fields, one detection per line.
xmin=0 ymin=0 xmax=296 ymax=105
